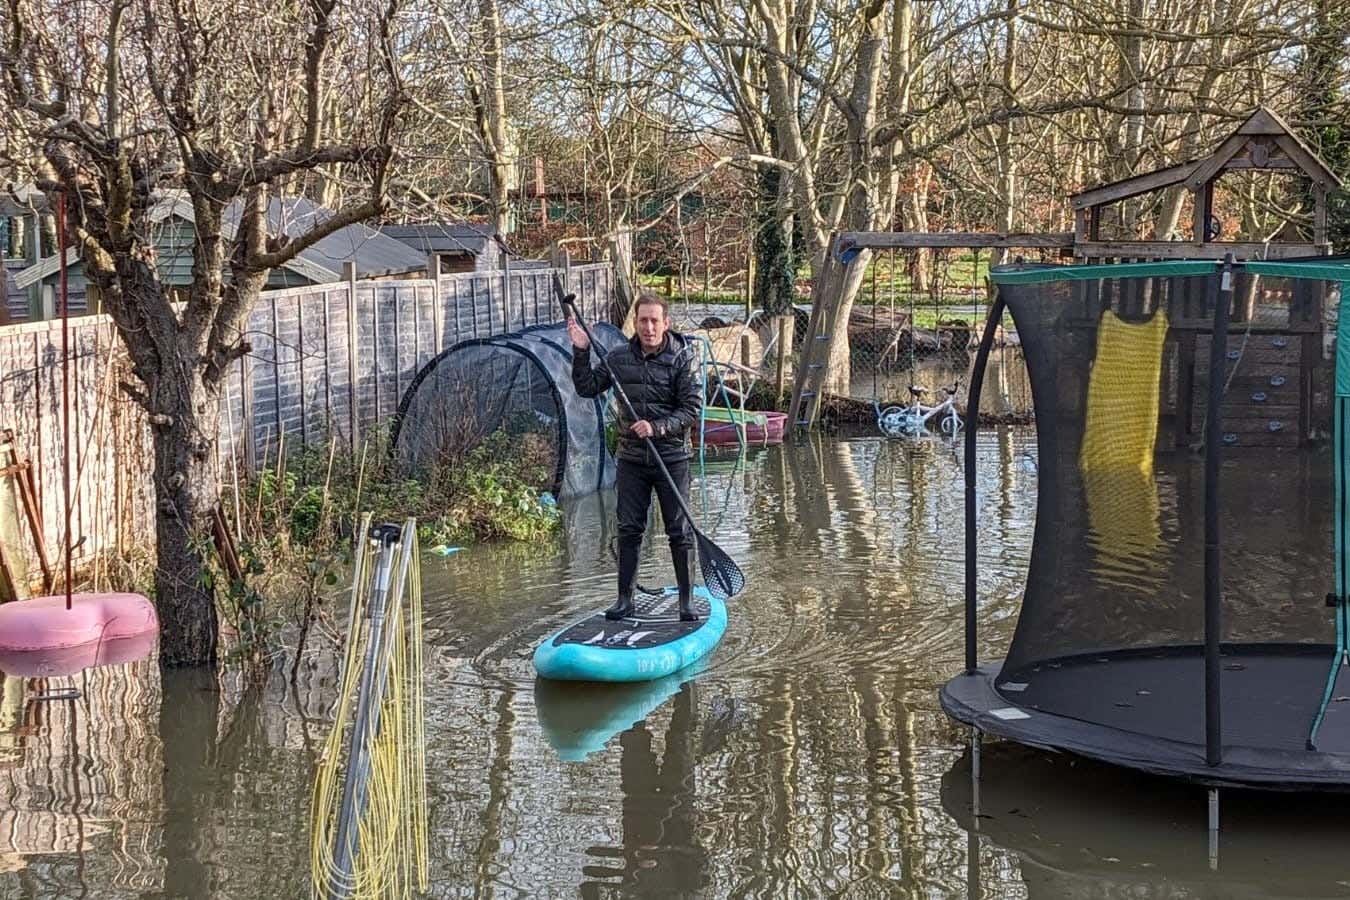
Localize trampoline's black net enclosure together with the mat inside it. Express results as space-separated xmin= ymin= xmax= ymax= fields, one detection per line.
xmin=994 ymin=260 xmax=1350 ymax=752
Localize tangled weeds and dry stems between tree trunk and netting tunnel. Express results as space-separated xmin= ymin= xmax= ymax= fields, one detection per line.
xmin=205 ymin=426 xmax=560 ymax=680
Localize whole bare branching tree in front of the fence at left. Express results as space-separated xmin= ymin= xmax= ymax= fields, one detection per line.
xmin=0 ymin=0 xmax=402 ymax=665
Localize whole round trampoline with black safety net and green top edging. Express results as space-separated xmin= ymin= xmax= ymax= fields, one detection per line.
xmin=941 ymin=258 xmax=1350 ymax=789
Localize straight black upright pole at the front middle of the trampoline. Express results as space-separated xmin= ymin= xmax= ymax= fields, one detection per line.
xmin=1204 ymin=254 xmax=1233 ymax=765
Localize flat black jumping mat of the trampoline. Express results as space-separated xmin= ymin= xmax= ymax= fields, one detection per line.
xmin=998 ymin=645 xmax=1332 ymax=750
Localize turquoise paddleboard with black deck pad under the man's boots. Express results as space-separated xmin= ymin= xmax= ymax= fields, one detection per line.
xmin=535 ymin=587 xmax=726 ymax=681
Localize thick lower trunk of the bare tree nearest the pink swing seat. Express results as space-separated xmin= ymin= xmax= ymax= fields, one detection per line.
xmin=151 ymin=362 xmax=220 ymax=665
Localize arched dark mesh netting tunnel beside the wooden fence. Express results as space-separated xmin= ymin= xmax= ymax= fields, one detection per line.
xmin=394 ymin=324 xmax=624 ymax=498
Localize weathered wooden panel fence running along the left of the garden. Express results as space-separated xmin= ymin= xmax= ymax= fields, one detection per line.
xmin=0 ymin=264 xmax=613 ymax=580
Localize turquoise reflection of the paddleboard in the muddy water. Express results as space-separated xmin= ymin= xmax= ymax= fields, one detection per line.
xmin=535 ymin=665 xmax=703 ymax=762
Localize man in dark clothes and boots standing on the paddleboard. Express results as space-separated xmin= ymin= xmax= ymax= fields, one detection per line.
xmin=567 ymin=291 xmax=702 ymax=622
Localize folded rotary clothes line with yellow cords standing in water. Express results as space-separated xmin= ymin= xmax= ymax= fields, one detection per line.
xmin=311 ymin=514 xmax=428 ymax=900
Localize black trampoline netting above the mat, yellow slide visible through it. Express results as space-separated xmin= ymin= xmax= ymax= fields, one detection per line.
xmin=999 ymin=267 xmax=1338 ymax=714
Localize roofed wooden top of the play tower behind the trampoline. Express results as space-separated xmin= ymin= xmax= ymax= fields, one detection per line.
xmin=1071 ymin=107 xmax=1343 ymax=259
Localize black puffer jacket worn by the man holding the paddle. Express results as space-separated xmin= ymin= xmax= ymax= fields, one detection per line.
xmin=572 ymin=332 xmax=701 ymax=466
